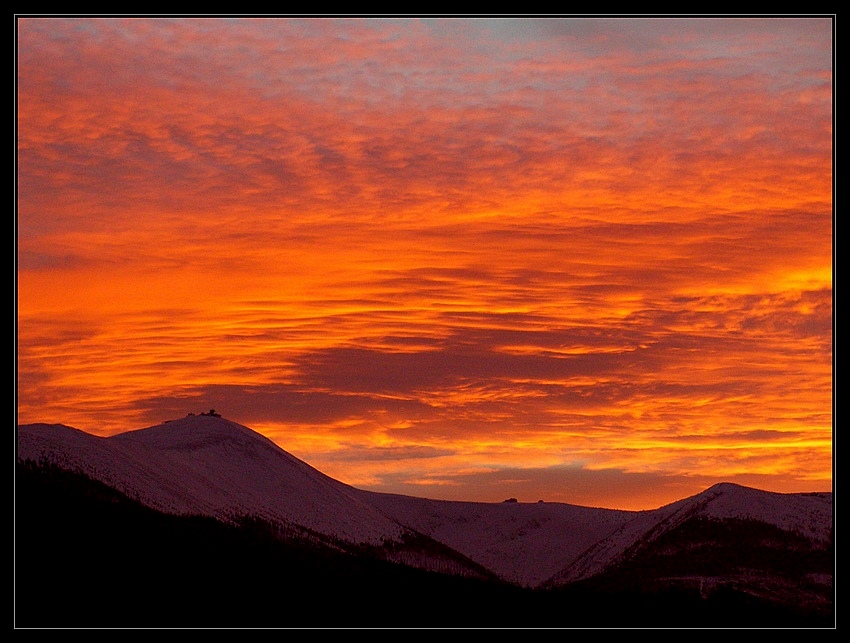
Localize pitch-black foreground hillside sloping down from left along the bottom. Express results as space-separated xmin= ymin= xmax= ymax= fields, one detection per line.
xmin=14 ymin=463 xmax=832 ymax=628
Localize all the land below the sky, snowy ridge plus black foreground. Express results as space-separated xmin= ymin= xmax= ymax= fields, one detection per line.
xmin=16 ymin=414 xmax=835 ymax=627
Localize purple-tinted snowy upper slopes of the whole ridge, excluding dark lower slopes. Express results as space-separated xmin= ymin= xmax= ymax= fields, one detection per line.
xmin=18 ymin=414 xmax=832 ymax=587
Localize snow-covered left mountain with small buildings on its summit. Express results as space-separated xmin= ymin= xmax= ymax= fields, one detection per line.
xmin=18 ymin=415 xmax=404 ymax=544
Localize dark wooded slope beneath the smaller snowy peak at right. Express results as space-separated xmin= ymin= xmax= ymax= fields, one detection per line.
xmin=552 ymin=518 xmax=835 ymax=627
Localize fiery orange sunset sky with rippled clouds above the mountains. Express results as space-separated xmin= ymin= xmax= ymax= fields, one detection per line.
xmin=16 ymin=16 xmax=834 ymax=509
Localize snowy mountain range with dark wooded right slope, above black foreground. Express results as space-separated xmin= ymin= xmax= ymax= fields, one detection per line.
xmin=17 ymin=414 xmax=834 ymax=622
